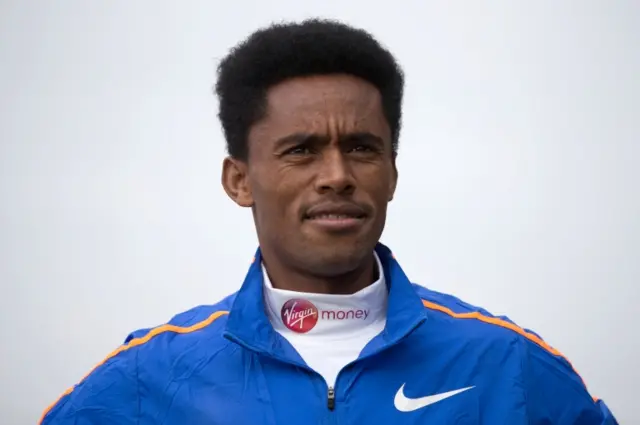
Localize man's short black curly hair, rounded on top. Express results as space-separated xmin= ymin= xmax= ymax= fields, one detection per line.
xmin=215 ymin=19 xmax=404 ymax=160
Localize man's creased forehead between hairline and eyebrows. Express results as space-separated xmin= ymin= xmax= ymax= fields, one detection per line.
xmin=249 ymin=75 xmax=391 ymax=149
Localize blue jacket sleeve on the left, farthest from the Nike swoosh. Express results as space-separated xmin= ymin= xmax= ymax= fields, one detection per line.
xmin=39 ymin=336 xmax=139 ymax=425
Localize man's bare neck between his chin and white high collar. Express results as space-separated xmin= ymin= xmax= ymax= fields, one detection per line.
xmin=263 ymin=253 xmax=378 ymax=295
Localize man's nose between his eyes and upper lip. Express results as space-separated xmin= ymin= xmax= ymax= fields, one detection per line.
xmin=316 ymin=149 xmax=356 ymax=195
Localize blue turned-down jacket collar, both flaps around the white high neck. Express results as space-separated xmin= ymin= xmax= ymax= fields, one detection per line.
xmin=225 ymin=243 xmax=427 ymax=363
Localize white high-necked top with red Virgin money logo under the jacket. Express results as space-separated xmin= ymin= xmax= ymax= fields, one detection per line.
xmin=262 ymin=253 xmax=388 ymax=386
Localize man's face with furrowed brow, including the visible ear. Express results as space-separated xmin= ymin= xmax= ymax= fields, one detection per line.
xmin=223 ymin=75 xmax=397 ymax=277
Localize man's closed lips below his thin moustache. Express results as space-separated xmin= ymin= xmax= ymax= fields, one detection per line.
xmin=304 ymin=204 xmax=367 ymax=232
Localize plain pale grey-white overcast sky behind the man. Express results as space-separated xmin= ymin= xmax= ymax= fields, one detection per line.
xmin=0 ymin=0 xmax=640 ymax=425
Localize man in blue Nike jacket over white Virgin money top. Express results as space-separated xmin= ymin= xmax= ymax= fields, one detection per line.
xmin=41 ymin=20 xmax=616 ymax=425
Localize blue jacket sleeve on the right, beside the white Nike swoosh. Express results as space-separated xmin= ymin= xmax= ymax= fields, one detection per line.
xmin=523 ymin=341 xmax=618 ymax=425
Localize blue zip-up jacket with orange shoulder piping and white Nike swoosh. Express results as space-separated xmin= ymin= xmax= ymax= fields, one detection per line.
xmin=41 ymin=244 xmax=617 ymax=425
